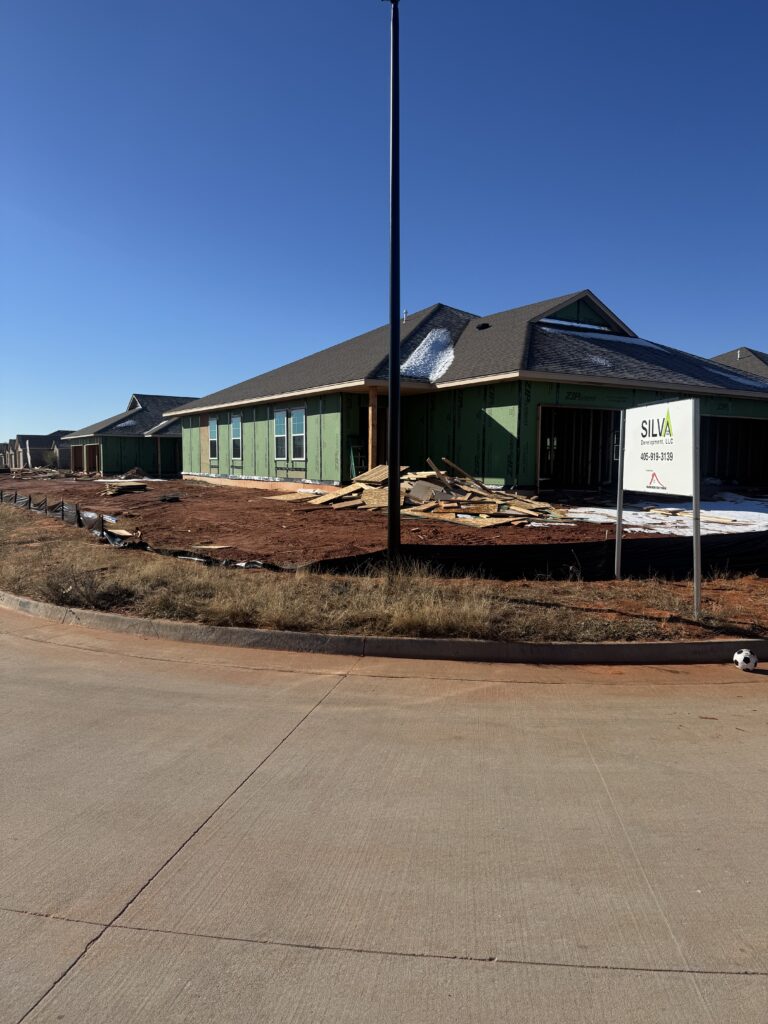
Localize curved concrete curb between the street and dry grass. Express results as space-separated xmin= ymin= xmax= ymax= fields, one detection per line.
xmin=0 ymin=591 xmax=768 ymax=665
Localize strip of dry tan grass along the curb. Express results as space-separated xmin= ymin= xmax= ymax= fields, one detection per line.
xmin=0 ymin=506 xmax=768 ymax=641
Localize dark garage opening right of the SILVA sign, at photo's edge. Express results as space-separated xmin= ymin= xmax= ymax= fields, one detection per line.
xmin=701 ymin=416 xmax=768 ymax=487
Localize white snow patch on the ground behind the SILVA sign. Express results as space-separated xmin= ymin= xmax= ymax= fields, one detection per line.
xmin=566 ymin=492 xmax=768 ymax=537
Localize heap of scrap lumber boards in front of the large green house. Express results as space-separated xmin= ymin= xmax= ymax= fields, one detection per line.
xmin=284 ymin=459 xmax=559 ymax=528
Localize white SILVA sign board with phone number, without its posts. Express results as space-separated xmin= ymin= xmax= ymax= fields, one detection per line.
xmin=624 ymin=398 xmax=695 ymax=498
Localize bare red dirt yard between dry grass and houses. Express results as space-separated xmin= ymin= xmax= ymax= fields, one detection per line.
xmin=0 ymin=478 xmax=630 ymax=566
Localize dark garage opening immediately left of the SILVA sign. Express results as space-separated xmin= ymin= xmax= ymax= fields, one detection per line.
xmin=539 ymin=406 xmax=620 ymax=490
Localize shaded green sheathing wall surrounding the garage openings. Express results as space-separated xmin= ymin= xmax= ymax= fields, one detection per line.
xmin=512 ymin=381 xmax=768 ymax=487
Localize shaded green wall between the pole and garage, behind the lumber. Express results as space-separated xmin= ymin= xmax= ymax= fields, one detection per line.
xmin=402 ymin=383 xmax=518 ymax=484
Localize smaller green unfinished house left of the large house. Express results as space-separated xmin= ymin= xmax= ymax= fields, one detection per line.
xmin=63 ymin=394 xmax=196 ymax=476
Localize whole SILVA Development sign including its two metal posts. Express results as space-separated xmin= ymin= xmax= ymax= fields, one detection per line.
xmin=615 ymin=398 xmax=701 ymax=618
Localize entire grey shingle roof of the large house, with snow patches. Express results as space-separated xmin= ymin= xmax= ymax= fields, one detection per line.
xmin=167 ymin=289 xmax=768 ymax=417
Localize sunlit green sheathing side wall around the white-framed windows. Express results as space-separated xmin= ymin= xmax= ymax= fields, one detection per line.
xmin=193 ymin=395 xmax=344 ymax=482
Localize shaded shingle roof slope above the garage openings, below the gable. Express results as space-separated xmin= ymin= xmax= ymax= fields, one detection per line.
xmin=524 ymin=325 xmax=768 ymax=396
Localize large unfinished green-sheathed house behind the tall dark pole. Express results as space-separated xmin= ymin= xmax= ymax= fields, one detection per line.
xmin=168 ymin=290 xmax=768 ymax=489
